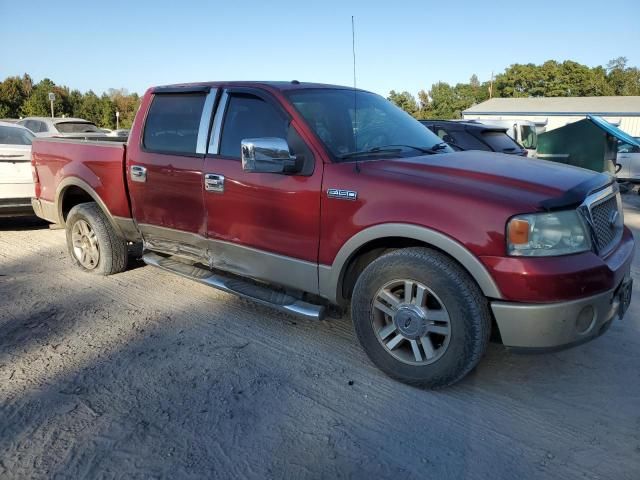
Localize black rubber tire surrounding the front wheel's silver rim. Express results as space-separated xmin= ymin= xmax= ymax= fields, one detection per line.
xmin=351 ymin=247 xmax=491 ymax=388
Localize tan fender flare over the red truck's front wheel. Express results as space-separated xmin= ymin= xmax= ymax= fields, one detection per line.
xmin=318 ymin=223 xmax=503 ymax=304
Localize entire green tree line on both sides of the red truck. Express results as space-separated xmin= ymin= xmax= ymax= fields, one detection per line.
xmin=0 ymin=57 xmax=640 ymax=129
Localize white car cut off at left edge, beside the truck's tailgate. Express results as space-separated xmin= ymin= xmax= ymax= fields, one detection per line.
xmin=0 ymin=122 xmax=35 ymax=217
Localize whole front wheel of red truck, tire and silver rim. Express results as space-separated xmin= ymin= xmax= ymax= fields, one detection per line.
xmin=351 ymin=247 xmax=491 ymax=388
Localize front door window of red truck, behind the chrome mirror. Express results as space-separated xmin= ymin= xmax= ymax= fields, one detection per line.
xmin=220 ymin=94 xmax=289 ymax=158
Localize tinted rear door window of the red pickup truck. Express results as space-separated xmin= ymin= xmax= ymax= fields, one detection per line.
xmin=142 ymin=93 xmax=205 ymax=154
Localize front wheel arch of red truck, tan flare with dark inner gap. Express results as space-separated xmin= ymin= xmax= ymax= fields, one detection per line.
xmin=318 ymin=223 xmax=502 ymax=306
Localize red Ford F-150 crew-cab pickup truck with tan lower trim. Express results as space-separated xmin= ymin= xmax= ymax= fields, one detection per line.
xmin=32 ymin=81 xmax=634 ymax=387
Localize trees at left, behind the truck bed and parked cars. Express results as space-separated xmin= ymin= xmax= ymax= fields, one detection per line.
xmin=0 ymin=73 xmax=140 ymax=129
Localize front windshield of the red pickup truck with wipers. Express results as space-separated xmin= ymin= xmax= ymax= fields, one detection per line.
xmin=288 ymin=88 xmax=453 ymax=161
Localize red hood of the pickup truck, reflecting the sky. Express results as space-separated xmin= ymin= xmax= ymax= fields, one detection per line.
xmin=365 ymin=151 xmax=613 ymax=210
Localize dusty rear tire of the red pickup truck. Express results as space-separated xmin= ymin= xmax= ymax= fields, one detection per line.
xmin=66 ymin=202 xmax=128 ymax=275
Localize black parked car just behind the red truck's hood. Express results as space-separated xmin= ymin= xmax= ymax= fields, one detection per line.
xmin=420 ymin=120 xmax=527 ymax=156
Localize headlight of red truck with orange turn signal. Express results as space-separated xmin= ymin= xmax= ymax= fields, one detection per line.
xmin=507 ymin=210 xmax=591 ymax=257
